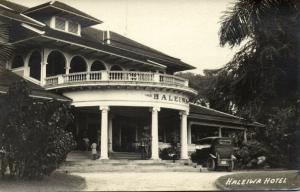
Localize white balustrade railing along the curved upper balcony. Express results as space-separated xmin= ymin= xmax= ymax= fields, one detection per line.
xmin=45 ymin=71 xmax=188 ymax=87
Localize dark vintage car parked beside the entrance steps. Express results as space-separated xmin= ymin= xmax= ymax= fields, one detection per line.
xmin=196 ymin=137 xmax=236 ymax=171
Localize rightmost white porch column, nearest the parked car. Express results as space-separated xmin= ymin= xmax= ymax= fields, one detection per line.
xmin=179 ymin=111 xmax=188 ymax=159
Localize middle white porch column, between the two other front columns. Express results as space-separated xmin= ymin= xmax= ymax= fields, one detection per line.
xmin=151 ymin=107 xmax=160 ymax=160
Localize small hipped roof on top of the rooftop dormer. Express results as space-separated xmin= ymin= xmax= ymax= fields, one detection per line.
xmin=23 ymin=1 xmax=102 ymax=27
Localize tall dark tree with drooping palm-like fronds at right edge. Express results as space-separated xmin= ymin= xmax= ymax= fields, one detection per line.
xmin=215 ymin=0 xmax=300 ymax=166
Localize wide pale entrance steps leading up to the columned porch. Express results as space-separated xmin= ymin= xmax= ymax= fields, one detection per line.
xmin=57 ymin=152 xmax=200 ymax=173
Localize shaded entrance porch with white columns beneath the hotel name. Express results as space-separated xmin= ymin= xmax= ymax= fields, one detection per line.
xmin=73 ymin=106 xmax=188 ymax=160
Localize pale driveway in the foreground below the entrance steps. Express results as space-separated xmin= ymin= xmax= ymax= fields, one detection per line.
xmin=72 ymin=172 xmax=229 ymax=191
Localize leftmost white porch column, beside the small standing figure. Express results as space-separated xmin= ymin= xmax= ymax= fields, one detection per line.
xmin=100 ymin=106 xmax=109 ymax=159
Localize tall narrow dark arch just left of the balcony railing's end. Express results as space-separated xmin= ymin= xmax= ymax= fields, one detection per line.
xmin=28 ymin=51 xmax=42 ymax=80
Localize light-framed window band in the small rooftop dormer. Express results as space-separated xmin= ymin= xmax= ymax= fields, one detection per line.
xmin=50 ymin=16 xmax=81 ymax=36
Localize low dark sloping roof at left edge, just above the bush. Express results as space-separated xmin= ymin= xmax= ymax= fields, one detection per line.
xmin=0 ymin=69 xmax=71 ymax=102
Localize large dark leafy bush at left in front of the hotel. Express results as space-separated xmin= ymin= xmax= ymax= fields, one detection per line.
xmin=0 ymin=81 xmax=75 ymax=178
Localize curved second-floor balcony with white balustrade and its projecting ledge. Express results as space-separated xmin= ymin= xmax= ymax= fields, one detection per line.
xmin=44 ymin=70 xmax=196 ymax=94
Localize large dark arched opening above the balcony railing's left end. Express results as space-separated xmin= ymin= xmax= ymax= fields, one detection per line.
xmin=46 ymin=51 xmax=66 ymax=77
